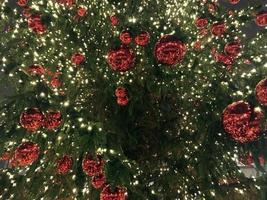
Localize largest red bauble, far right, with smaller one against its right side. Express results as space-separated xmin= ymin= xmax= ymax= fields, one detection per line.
xmin=223 ymin=101 xmax=263 ymax=143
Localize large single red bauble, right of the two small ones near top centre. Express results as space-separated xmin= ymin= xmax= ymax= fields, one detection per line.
xmin=154 ymin=35 xmax=186 ymax=65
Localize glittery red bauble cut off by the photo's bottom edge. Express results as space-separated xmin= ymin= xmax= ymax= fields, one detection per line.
xmin=100 ymin=185 xmax=127 ymax=200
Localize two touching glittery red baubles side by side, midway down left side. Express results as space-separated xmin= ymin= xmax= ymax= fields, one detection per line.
xmin=20 ymin=108 xmax=62 ymax=132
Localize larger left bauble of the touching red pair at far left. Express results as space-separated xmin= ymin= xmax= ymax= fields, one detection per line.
xmin=20 ymin=108 xmax=44 ymax=131
